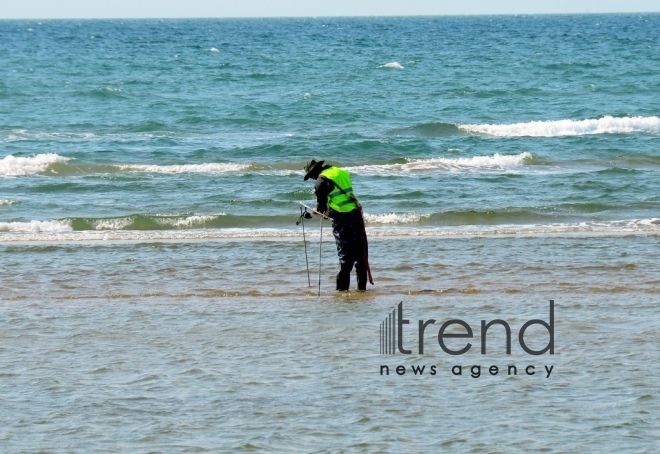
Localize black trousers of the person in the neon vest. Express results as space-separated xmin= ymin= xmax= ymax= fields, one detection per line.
xmin=330 ymin=210 xmax=367 ymax=290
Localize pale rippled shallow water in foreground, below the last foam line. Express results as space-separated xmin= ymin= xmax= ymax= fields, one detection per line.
xmin=0 ymin=237 xmax=659 ymax=452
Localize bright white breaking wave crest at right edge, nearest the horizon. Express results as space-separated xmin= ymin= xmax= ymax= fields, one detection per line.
xmin=458 ymin=115 xmax=660 ymax=137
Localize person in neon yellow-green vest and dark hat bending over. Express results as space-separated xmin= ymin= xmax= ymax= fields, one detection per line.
xmin=304 ymin=159 xmax=374 ymax=291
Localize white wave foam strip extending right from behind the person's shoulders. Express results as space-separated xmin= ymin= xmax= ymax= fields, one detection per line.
xmin=350 ymin=152 xmax=532 ymax=175
